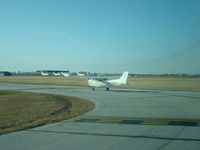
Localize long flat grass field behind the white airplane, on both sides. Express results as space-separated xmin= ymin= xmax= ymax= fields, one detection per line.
xmin=0 ymin=76 xmax=200 ymax=92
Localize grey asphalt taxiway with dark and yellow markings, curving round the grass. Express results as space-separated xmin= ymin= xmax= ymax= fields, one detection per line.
xmin=0 ymin=83 xmax=200 ymax=150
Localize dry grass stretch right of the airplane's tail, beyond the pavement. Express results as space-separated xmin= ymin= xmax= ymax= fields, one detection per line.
xmin=124 ymin=77 xmax=200 ymax=92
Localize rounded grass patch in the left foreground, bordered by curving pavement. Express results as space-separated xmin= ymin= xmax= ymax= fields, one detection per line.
xmin=0 ymin=91 xmax=94 ymax=134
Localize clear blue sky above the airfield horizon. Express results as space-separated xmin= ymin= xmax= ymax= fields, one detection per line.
xmin=0 ymin=0 xmax=200 ymax=74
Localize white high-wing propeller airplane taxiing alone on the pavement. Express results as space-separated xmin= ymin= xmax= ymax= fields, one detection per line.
xmin=88 ymin=72 xmax=128 ymax=91
